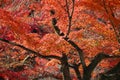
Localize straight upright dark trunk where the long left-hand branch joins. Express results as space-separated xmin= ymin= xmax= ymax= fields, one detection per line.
xmin=61 ymin=54 xmax=71 ymax=80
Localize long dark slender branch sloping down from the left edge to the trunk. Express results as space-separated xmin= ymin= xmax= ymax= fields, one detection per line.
xmin=0 ymin=38 xmax=61 ymax=60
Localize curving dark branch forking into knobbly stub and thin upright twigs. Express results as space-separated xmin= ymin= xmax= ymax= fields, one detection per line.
xmin=52 ymin=0 xmax=86 ymax=70
